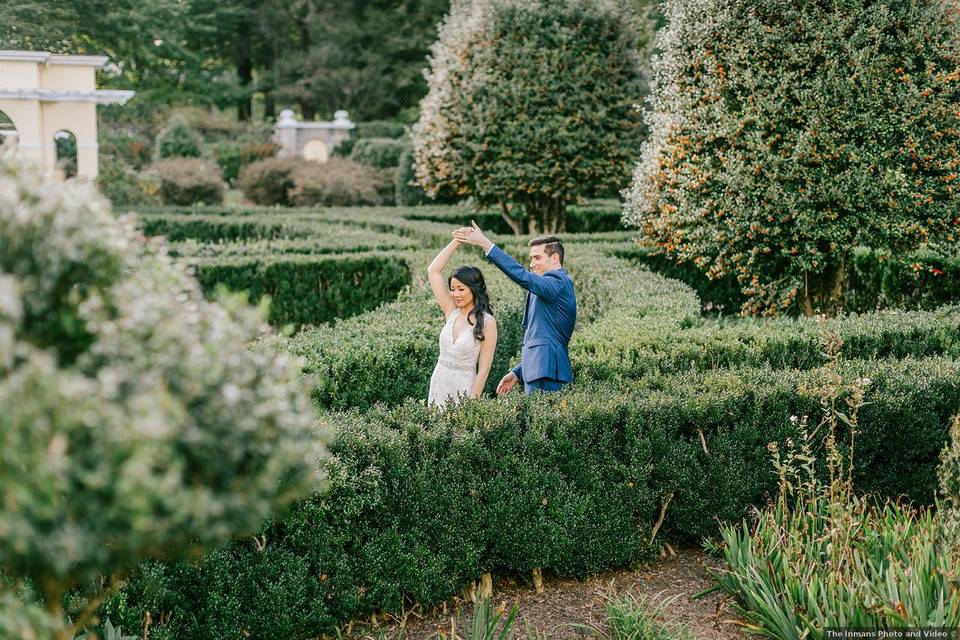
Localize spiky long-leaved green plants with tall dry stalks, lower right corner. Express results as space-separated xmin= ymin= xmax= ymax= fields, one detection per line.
xmin=704 ymin=374 xmax=960 ymax=640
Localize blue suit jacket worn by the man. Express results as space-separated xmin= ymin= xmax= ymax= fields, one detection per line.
xmin=487 ymin=245 xmax=577 ymax=382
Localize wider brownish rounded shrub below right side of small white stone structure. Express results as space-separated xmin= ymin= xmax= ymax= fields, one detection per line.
xmin=289 ymin=158 xmax=393 ymax=207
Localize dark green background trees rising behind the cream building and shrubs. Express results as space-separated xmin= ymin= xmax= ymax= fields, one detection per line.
xmin=0 ymin=0 xmax=448 ymax=121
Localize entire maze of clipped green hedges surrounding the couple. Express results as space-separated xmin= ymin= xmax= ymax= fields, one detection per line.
xmin=118 ymin=203 xmax=960 ymax=640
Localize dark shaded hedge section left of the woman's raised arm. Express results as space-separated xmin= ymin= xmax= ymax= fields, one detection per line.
xmin=189 ymin=253 xmax=410 ymax=326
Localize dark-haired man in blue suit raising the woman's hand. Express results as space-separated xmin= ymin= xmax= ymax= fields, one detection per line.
xmin=453 ymin=222 xmax=577 ymax=395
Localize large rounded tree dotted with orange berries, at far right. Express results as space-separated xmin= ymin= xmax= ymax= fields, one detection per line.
xmin=625 ymin=0 xmax=960 ymax=314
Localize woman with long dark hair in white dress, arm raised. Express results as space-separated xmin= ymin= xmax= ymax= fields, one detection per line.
xmin=427 ymin=240 xmax=497 ymax=407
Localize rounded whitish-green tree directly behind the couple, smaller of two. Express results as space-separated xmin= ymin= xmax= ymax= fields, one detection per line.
xmin=413 ymin=0 xmax=643 ymax=234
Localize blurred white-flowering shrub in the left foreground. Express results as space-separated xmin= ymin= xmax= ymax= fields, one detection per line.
xmin=0 ymin=160 xmax=322 ymax=637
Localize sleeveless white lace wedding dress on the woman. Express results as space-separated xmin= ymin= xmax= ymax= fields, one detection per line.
xmin=427 ymin=309 xmax=492 ymax=407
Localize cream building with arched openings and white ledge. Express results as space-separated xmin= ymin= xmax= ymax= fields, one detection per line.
xmin=0 ymin=51 xmax=133 ymax=178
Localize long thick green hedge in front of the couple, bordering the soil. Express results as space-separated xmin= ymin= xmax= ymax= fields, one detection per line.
xmin=105 ymin=358 xmax=960 ymax=640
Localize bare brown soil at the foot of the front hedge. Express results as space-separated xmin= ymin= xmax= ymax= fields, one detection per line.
xmin=346 ymin=548 xmax=748 ymax=640
